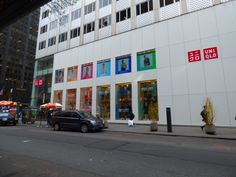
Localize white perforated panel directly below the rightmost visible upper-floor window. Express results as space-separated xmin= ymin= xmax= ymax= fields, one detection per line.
xmin=160 ymin=2 xmax=181 ymax=20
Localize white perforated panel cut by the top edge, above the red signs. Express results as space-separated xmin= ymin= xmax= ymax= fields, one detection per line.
xmin=186 ymin=0 xmax=213 ymax=12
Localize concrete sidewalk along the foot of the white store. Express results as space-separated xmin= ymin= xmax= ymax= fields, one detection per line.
xmin=33 ymin=121 xmax=236 ymax=140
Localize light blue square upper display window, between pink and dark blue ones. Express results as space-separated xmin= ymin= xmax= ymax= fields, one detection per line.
xmin=97 ymin=59 xmax=111 ymax=77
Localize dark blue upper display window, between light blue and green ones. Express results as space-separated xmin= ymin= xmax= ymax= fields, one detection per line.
xmin=116 ymin=55 xmax=131 ymax=74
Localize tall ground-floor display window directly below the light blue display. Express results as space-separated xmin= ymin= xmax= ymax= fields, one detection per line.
xmin=96 ymin=86 xmax=110 ymax=120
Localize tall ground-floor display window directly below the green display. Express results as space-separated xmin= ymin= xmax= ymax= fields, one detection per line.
xmin=138 ymin=80 xmax=158 ymax=120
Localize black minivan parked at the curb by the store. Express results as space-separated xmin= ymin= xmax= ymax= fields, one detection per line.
xmin=51 ymin=111 xmax=103 ymax=133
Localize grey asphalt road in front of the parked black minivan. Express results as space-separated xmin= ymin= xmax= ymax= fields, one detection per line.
xmin=0 ymin=126 xmax=236 ymax=177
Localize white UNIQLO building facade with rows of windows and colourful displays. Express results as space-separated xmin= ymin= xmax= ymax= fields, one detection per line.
xmin=32 ymin=0 xmax=236 ymax=127
